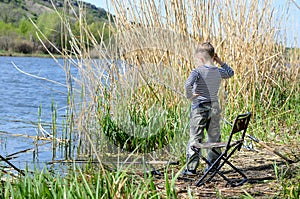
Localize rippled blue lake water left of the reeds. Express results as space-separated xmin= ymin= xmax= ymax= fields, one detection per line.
xmin=0 ymin=57 xmax=76 ymax=169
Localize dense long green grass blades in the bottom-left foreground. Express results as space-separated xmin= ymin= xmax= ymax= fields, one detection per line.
xmin=0 ymin=168 xmax=165 ymax=198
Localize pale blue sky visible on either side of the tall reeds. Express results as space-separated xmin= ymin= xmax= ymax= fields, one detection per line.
xmin=83 ymin=0 xmax=300 ymax=47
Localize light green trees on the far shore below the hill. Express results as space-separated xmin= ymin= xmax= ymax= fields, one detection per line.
xmin=0 ymin=0 xmax=109 ymax=53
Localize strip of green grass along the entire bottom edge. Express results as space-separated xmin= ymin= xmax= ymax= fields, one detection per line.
xmin=0 ymin=156 xmax=299 ymax=198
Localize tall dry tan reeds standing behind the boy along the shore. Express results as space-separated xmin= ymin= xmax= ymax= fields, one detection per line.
xmin=41 ymin=0 xmax=299 ymax=165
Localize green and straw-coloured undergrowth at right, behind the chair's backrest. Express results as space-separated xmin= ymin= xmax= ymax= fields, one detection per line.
xmin=222 ymin=67 xmax=300 ymax=143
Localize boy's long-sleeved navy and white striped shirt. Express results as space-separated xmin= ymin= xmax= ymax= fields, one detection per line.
xmin=185 ymin=63 xmax=234 ymax=109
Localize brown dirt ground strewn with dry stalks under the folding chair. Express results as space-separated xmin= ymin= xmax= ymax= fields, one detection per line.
xmin=155 ymin=144 xmax=300 ymax=198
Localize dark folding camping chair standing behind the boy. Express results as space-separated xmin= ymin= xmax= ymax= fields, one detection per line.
xmin=191 ymin=112 xmax=251 ymax=186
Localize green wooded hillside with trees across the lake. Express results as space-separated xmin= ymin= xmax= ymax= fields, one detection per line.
xmin=0 ymin=0 xmax=109 ymax=54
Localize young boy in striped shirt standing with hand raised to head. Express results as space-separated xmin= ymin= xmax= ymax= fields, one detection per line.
xmin=183 ymin=42 xmax=234 ymax=175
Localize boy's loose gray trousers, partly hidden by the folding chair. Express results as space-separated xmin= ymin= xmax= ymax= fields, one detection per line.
xmin=186 ymin=102 xmax=221 ymax=171
